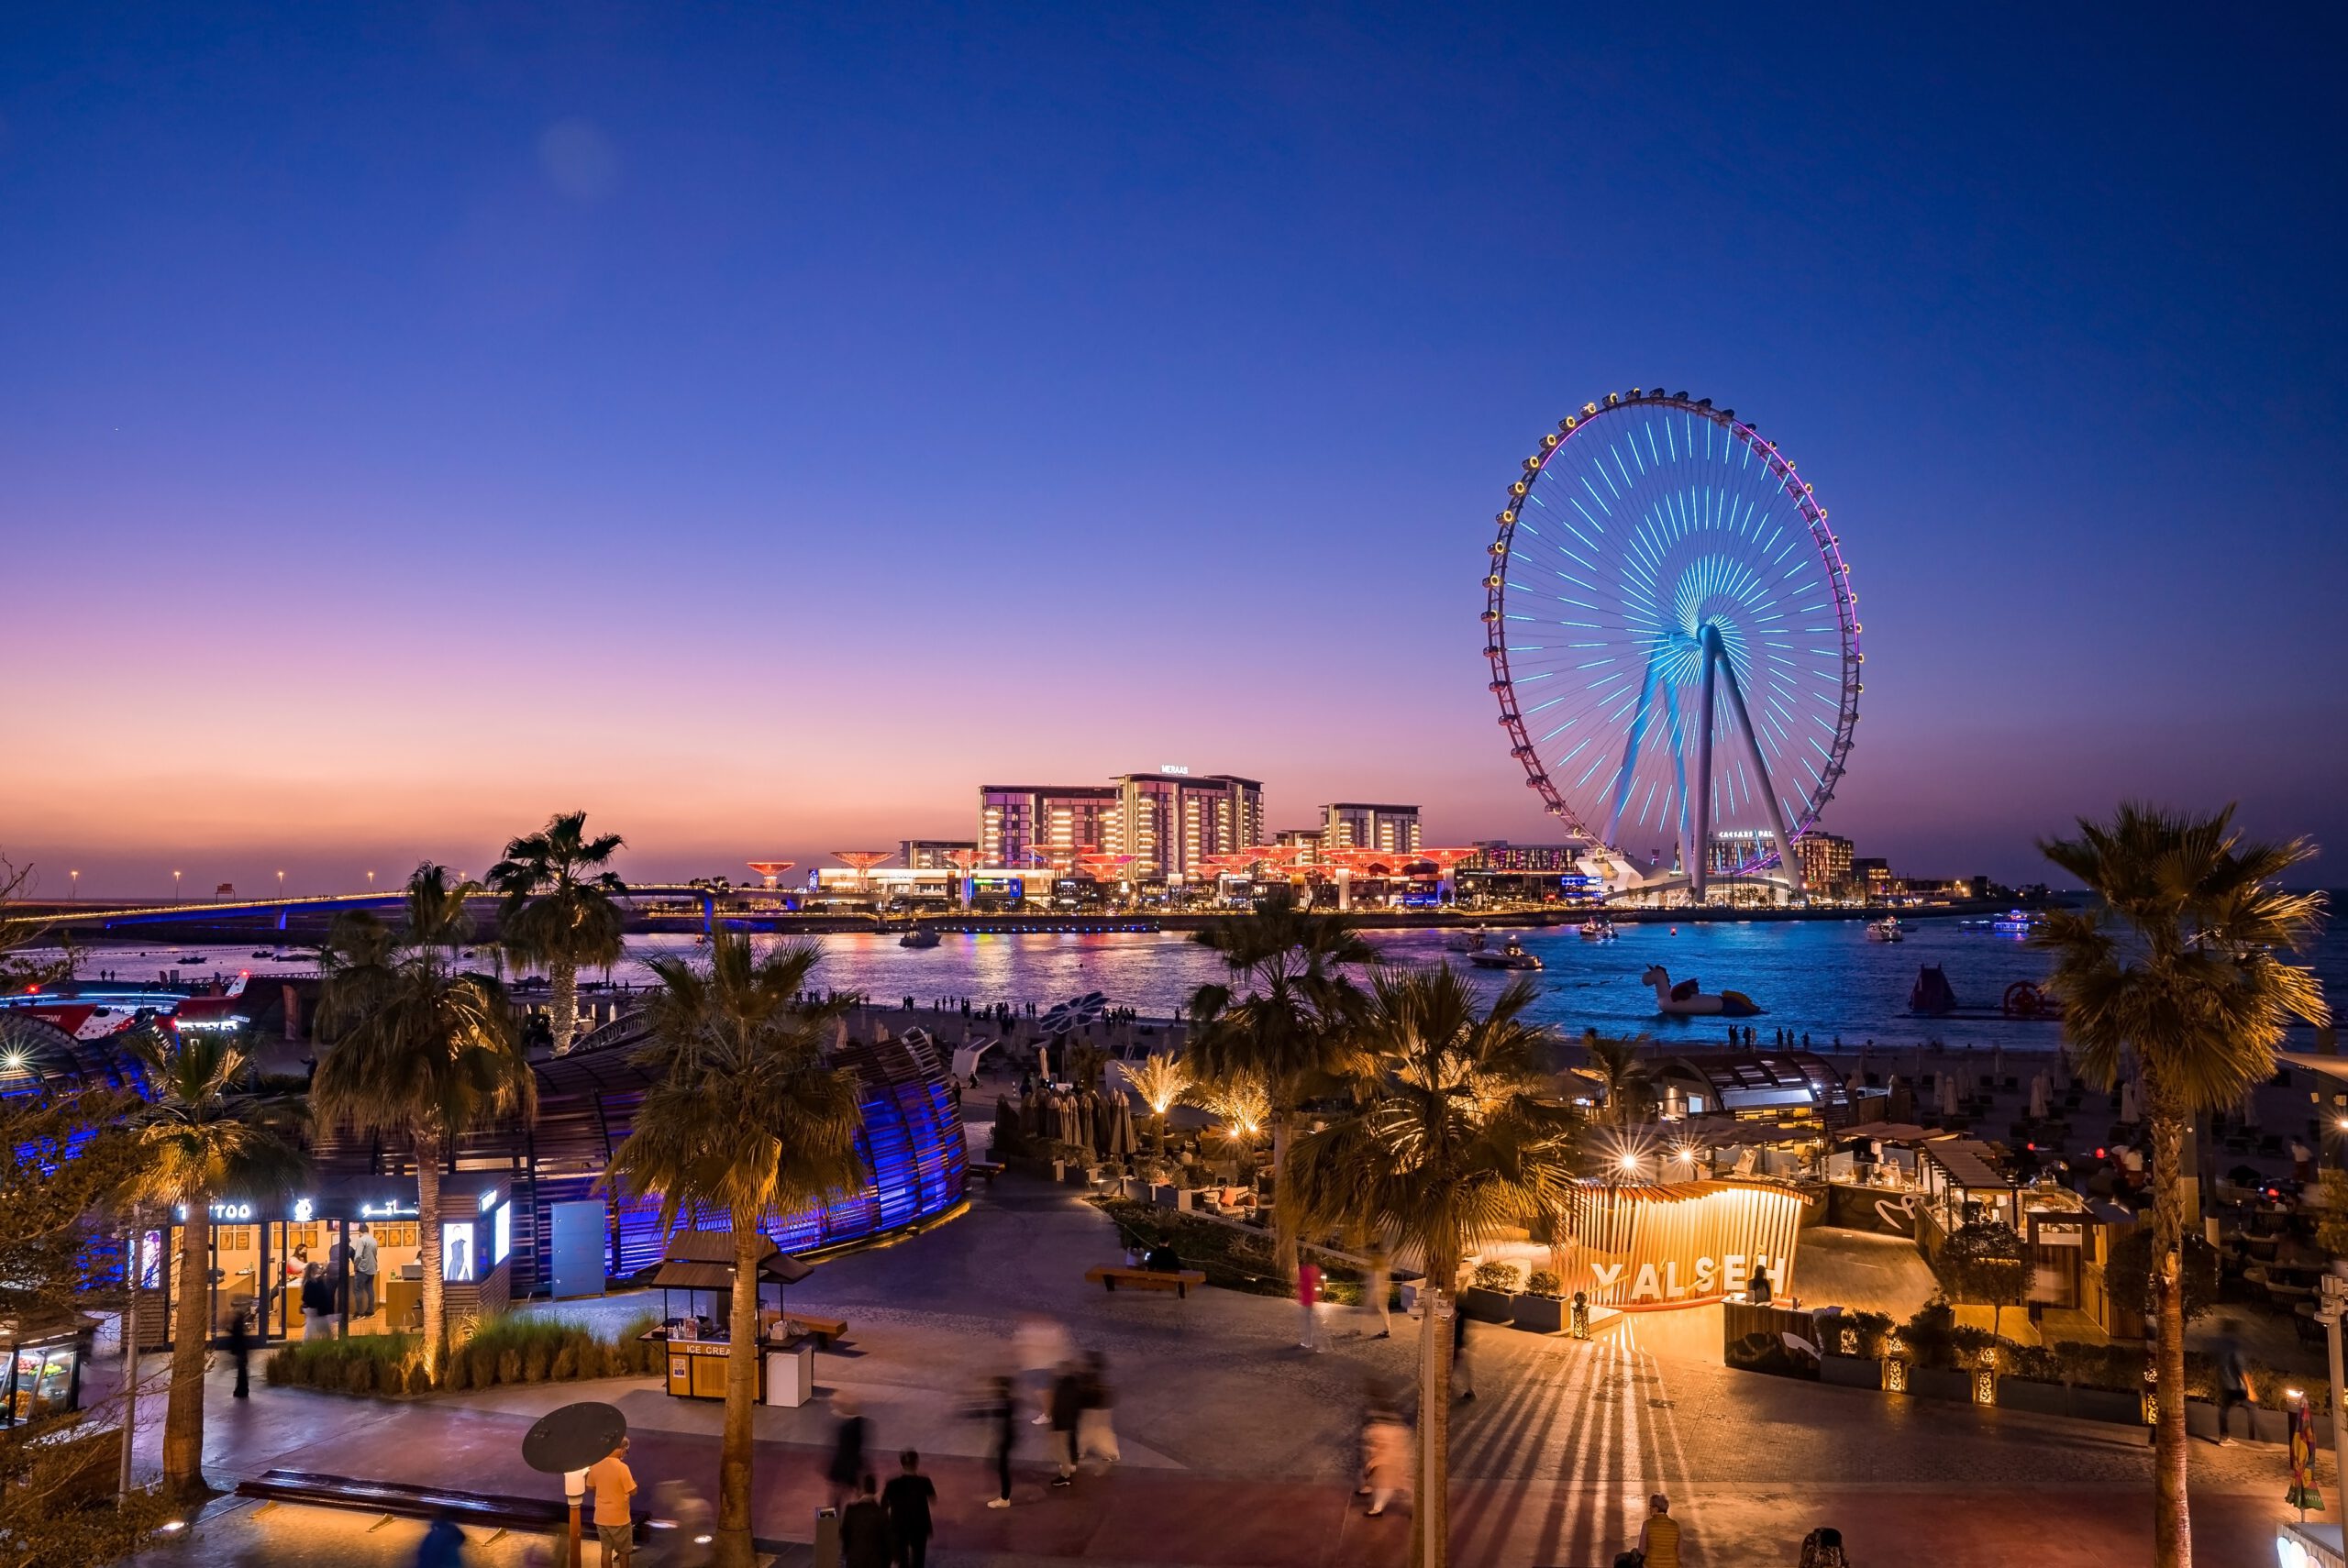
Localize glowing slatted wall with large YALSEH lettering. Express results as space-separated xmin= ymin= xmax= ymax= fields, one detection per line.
xmin=1564 ymin=1181 xmax=1806 ymax=1308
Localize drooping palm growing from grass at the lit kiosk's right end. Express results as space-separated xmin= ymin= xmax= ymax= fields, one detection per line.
xmin=310 ymin=861 xmax=537 ymax=1378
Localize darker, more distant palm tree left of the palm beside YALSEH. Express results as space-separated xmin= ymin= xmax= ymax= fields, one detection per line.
xmin=1188 ymin=897 xmax=1379 ymax=1279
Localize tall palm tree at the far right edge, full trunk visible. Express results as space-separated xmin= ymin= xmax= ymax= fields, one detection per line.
xmin=2036 ymin=802 xmax=2324 ymax=1568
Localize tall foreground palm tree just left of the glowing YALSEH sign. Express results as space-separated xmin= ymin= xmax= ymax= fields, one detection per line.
xmin=1294 ymin=965 xmax=1573 ymax=1568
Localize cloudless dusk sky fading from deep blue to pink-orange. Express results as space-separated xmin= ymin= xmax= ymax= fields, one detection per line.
xmin=0 ymin=5 xmax=2348 ymax=894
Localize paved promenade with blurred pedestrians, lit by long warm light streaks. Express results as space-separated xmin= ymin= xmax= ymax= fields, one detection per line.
xmin=133 ymin=1176 xmax=2336 ymax=1568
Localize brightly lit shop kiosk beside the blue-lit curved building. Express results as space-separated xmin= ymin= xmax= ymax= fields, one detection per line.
xmin=131 ymin=1171 xmax=515 ymax=1350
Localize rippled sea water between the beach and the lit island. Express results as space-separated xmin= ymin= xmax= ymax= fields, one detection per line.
xmin=59 ymin=894 xmax=2348 ymax=1049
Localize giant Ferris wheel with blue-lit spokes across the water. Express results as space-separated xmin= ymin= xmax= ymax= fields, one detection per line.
xmin=1484 ymin=387 xmax=1862 ymax=894
